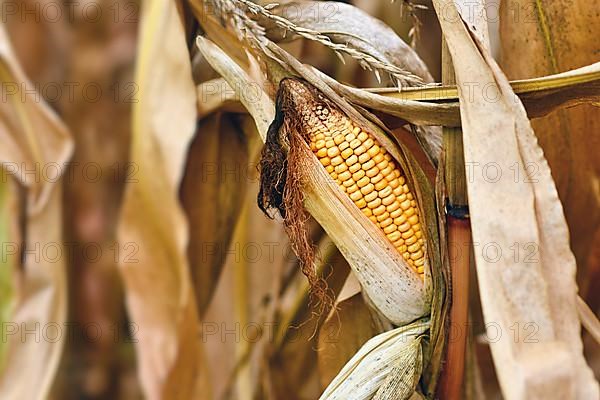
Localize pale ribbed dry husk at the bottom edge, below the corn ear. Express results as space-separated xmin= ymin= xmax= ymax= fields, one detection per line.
xmin=320 ymin=320 xmax=429 ymax=400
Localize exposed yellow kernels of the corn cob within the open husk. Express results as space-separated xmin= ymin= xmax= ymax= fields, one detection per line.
xmin=302 ymin=96 xmax=425 ymax=274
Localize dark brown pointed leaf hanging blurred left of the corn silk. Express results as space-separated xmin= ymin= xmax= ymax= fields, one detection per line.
xmin=181 ymin=113 xmax=249 ymax=315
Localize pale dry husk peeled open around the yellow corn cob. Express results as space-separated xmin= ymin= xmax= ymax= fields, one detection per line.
xmin=197 ymin=37 xmax=437 ymax=324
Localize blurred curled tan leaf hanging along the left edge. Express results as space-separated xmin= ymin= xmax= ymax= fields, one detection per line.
xmin=0 ymin=26 xmax=73 ymax=400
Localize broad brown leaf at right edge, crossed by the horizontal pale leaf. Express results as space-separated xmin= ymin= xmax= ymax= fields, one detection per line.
xmin=500 ymin=0 xmax=600 ymax=304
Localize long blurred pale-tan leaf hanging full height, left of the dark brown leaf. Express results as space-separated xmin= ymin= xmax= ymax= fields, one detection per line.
xmin=118 ymin=0 xmax=210 ymax=399
